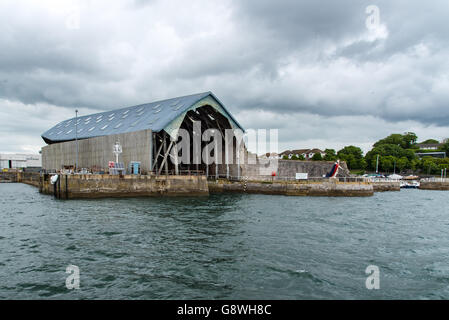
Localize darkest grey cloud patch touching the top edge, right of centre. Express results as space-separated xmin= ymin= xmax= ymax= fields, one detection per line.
xmin=235 ymin=0 xmax=371 ymax=42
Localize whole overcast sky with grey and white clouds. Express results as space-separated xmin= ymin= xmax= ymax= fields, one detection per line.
xmin=0 ymin=0 xmax=449 ymax=152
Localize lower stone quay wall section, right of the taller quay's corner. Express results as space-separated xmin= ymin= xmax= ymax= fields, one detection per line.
xmin=209 ymin=179 xmax=374 ymax=197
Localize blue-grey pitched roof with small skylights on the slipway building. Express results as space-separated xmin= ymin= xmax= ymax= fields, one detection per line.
xmin=42 ymin=92 xmax=243 ymax=143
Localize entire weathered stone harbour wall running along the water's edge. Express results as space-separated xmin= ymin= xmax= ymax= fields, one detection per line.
xmin=0 ymin=172 xmax=402 ymax=199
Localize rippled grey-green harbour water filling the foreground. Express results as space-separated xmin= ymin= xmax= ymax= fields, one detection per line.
xmin=0 ymin=184 xmax=449 ymax=299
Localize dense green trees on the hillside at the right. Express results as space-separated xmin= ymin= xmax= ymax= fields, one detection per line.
xmin=284 ymin=132 xmax=449 ymax=174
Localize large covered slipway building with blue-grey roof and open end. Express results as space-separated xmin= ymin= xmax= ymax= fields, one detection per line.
xmin=42 ymin=92 xmax=245 ymax=176
